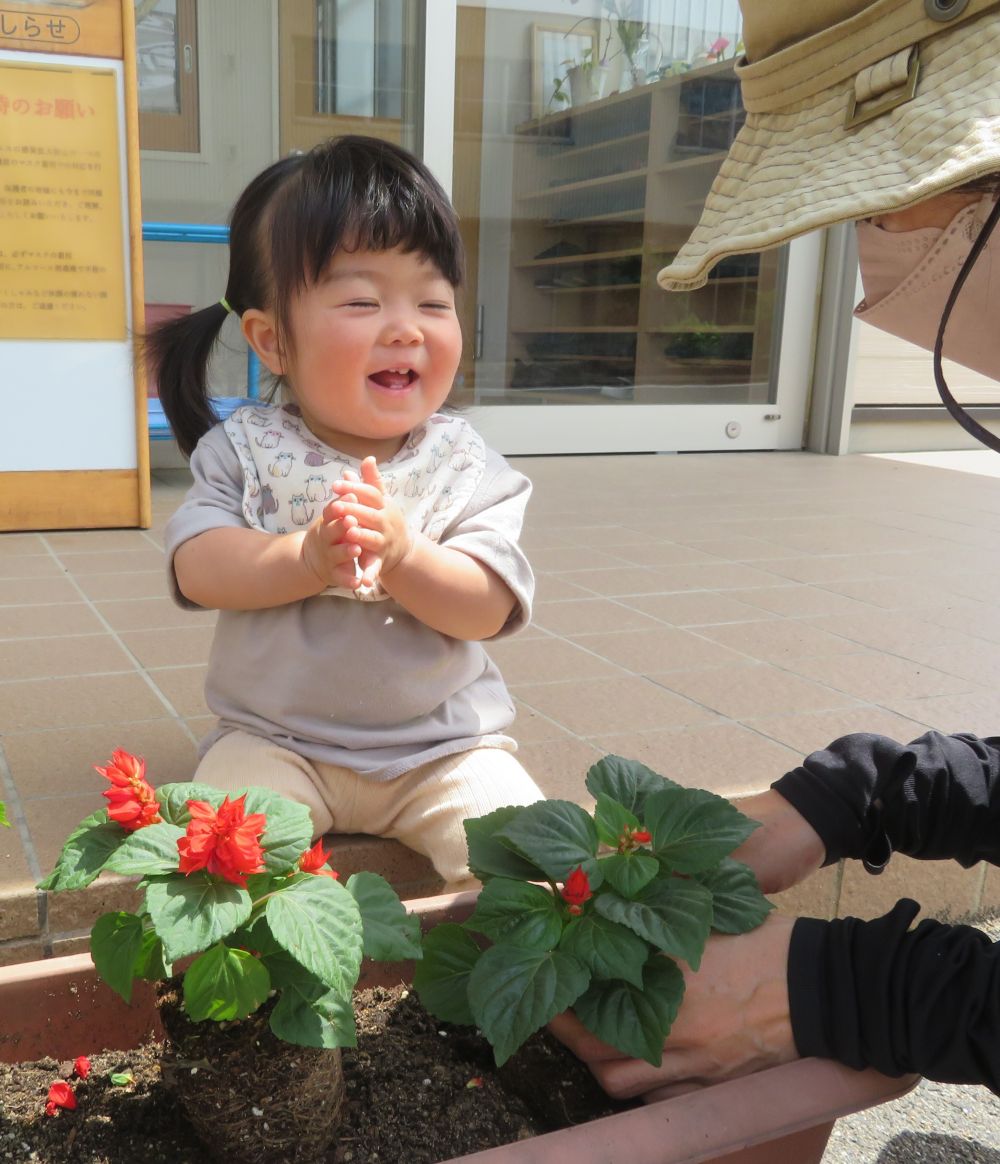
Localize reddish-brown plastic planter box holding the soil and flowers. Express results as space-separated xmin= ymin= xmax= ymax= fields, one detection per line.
xmin=0 ymin=893 xmax=917 ymax=1164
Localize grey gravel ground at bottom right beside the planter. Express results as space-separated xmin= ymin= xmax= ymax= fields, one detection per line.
xmin=823 ymin=918 xmax=1000 ymax=1164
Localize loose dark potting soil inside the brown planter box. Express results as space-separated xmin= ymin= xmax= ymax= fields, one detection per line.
xmin=0 ymin=986 xmax=622 ymax=1164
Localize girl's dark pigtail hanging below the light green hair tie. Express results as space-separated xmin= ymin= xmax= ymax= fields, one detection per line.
xmin=143 ymin=303 xmax=228 ymax=456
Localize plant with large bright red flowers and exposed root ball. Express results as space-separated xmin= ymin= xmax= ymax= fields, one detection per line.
xmin=40 ymin=750 xmax=420 ymax=1162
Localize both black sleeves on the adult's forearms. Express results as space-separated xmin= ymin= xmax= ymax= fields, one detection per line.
xmin=773 ymin=732 xmax=1000 ymax=1094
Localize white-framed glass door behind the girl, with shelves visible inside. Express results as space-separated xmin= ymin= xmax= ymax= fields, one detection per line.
xmin=433 ymin=0 xmax=821 ymax=454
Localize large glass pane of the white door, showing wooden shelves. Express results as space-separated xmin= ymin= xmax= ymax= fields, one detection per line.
xmin=455 ymin=0 xmax=783 ymax=405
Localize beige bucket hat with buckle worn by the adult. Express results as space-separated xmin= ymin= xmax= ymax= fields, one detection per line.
xmin=658 ymin=0 xmax=1000 ymax=291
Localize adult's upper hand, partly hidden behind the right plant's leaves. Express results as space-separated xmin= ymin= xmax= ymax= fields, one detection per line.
xmin=732 ymin=788 xmax=827 ymax=893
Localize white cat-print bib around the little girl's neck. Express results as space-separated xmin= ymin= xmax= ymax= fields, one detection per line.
xmin=224 ymin=404 xmax=485 ymax=602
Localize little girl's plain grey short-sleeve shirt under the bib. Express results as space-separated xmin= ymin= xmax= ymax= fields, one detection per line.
xmin=165 ymin=425 xmax=534 ymax=780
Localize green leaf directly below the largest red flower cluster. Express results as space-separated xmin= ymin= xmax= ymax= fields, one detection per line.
xmin=146 ymin=870 xmax=253 ymax=961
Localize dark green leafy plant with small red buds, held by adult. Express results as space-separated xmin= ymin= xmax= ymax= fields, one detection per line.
xmin=414 ymin=757 xmax=772 ymax=1065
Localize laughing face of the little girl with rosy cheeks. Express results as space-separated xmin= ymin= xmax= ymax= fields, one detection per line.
xmin=259 ymin=249 xmax=462 ymax=461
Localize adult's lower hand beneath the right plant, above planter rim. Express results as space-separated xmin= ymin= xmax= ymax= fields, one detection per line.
xmin=548 ymin=914 xmax=799 ymax=1102
